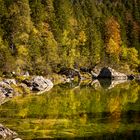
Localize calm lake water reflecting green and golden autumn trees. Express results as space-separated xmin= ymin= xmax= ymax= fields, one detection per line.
xmin=0 ymin=81 xmax=140 ymax=140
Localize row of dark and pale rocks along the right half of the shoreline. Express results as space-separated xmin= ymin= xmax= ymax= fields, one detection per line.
xmin=58 ymin=67 xmax=140 ymax=81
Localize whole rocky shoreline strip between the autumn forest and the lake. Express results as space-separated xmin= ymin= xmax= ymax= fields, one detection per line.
xmin=0 ymin=67 xmax=140 ymax=100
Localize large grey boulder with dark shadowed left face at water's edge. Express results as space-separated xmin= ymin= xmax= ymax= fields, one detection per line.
xmin=97 ymin=67 xmax=128 ymax=80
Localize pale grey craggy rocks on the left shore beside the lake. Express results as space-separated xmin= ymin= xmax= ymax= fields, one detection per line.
xmin=0 ymin=76 xmax=53 ymax=105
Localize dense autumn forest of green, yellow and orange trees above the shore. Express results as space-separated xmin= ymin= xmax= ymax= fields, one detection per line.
xmin=0 ymin=0 xmax=140 ymax=74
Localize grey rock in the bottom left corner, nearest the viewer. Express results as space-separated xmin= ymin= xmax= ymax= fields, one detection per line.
xmin=0 ymin=124 xmax=17 ymax=140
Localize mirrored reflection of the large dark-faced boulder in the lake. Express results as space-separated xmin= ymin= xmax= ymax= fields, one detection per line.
xmin=91 ymin=79 xmax=127 ymax=89
